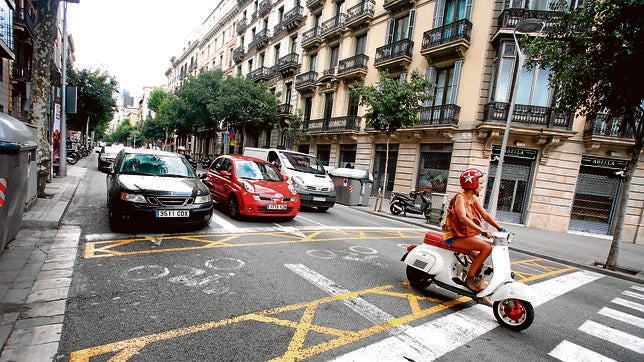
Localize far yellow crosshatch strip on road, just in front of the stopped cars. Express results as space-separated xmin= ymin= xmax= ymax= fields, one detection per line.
xmin=83 ymin=229 xmax=427 ymax=259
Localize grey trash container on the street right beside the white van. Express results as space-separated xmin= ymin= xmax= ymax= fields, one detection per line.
xmin=329 ymin=168 xmax=373 ymax=206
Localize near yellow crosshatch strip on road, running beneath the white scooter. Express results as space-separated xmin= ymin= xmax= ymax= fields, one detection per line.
xmin=70 ymin=258 xmax=576 ymax=362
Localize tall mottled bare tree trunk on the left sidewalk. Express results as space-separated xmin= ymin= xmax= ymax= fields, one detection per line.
xmin=28 ymin=0 xmax=59 ymax=197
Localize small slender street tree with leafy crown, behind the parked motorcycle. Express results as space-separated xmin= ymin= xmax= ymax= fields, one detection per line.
xmin=349 ymin=70 xmax=434 ymax=201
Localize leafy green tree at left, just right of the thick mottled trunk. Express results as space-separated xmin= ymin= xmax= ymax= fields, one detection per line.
xmin=67 ymin=66 xmax=118 ymax=138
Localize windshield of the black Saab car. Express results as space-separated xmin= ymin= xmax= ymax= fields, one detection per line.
xmin=119 ymin=154 xmax=195 ymax=177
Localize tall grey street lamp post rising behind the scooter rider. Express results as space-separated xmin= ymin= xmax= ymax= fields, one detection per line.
xmin=488 ymin=19 xmax=546 ymax=218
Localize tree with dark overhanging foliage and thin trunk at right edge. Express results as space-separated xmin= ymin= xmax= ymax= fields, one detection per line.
xmin=525 ymin=0 xmax=644 ymax=270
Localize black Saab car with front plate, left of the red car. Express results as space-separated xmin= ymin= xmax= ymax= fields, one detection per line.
xmin=104 ymin=148 xmax=213 ymax=231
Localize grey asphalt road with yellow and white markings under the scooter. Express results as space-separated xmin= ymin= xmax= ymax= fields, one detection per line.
xmin=59 ymin=165 xmax=644 ymax=361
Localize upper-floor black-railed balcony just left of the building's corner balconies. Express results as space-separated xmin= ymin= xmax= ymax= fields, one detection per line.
xmin=420 ymin=19 xmax=472 ymax=64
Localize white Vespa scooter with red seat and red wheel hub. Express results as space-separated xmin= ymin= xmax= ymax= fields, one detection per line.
xmin=401 ymin=231 xmax=534 ymax=331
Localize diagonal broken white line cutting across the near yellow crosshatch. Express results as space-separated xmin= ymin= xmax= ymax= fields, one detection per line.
xmin=284 ymin=264 xmax=428 ymax=354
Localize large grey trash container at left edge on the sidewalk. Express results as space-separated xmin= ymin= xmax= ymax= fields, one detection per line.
xmin=0 ymin=113 xmax=37 ymax=253
